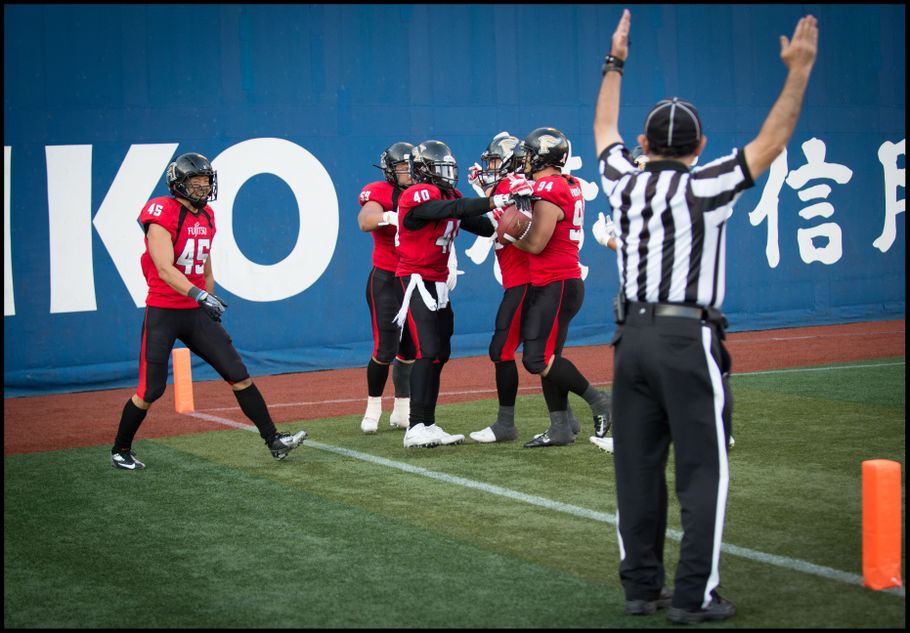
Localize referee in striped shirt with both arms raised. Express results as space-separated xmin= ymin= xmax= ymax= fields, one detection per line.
xmin=594 ymin=10 xmax=818 ymax=624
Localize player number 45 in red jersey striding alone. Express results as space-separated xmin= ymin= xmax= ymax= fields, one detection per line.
xmin=111 ymin=153 xmax=307 ymax=470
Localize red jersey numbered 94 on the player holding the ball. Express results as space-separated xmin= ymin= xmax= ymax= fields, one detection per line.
xmin=528 ymin=174 xmax=585 ymax=286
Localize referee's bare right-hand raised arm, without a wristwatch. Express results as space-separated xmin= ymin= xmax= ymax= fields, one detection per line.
xmin=744 ymin=15 xmax=818 ymax=179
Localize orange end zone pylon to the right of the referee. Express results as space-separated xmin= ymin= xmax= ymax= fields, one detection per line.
xmin=863 ymin=459 xmax=903 ymax=590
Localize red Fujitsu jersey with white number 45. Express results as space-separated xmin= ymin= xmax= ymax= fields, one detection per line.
xmin=139 ymin=196 xmax=215 ymax=309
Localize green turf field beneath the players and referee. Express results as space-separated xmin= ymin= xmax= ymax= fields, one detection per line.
xmin=4 ymin=357 xmax=906 ymax=628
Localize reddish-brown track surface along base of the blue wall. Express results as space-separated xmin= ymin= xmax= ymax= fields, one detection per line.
xmin=3 ymin=320 xmax=905 ymax=455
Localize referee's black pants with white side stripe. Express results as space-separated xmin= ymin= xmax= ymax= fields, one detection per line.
xmin=613 ymin=303 xmax=732 ymax=610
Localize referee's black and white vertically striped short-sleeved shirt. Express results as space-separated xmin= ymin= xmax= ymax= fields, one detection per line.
xmin=600 ymin=143 xmax=755 ymax=308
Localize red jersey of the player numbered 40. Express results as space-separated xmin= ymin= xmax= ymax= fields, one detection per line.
xmin=395 ymin=183 xmax=461 ymax=281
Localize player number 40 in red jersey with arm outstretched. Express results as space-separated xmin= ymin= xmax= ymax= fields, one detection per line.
xmin=396 ymin=141 xmax=528 ymax=448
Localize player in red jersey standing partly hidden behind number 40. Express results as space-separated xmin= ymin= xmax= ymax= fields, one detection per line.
xmin=357 ymin=142 xmax=415 ymax=433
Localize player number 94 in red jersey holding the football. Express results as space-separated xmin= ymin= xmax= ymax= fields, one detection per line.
xmin=506 ymin=127 xmax=612 ymax=448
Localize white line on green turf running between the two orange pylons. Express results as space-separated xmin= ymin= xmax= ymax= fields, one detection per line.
xmin=184 ymin=404 xmax=904 ymax=597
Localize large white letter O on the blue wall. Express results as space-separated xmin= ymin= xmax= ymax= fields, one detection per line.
xmin=211 ymin=138 xmax=338 ymax=301
